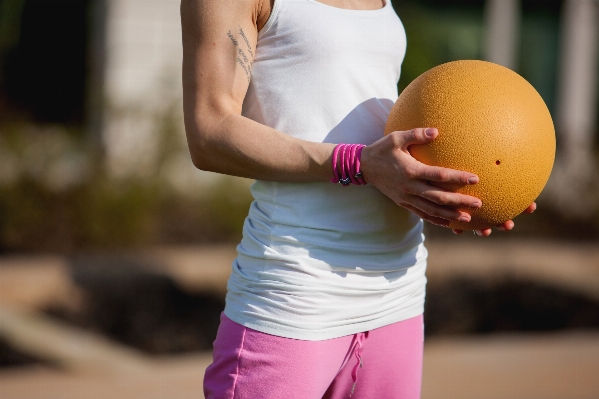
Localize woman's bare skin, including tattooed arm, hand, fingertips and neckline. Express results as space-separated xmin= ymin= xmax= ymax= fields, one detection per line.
xmin=181 ymin=0 xmax=536 ymax=236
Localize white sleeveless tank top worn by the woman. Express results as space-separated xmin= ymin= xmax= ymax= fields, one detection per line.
xmin=225 ymin=0 xmax=427 ymax=340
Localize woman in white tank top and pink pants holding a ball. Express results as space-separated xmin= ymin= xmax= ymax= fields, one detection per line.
xmin=181 ymin=0 xmax=534 ymax=399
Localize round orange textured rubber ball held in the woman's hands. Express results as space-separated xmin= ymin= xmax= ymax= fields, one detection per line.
xmin=385 ymin=60 xmax=555 ymax=230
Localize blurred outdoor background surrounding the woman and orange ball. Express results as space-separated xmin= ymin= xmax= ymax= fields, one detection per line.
xmin=0 ymin=0 xmax=599 ymax=399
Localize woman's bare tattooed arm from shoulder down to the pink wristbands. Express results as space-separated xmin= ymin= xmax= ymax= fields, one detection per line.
xmin=181 ymin=0 xmax=334 ymax=182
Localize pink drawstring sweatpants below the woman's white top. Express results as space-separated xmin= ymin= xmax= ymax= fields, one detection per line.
xmin=204 ymin=314 xmax=423 ymax=399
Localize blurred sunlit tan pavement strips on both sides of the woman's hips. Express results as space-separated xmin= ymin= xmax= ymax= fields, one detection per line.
xmin=0 ymin=240 xmax=599 ymax=399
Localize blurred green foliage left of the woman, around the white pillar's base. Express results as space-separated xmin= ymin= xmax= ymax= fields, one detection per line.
xmin=0 ymin=109 xmax=251 ymax=253
